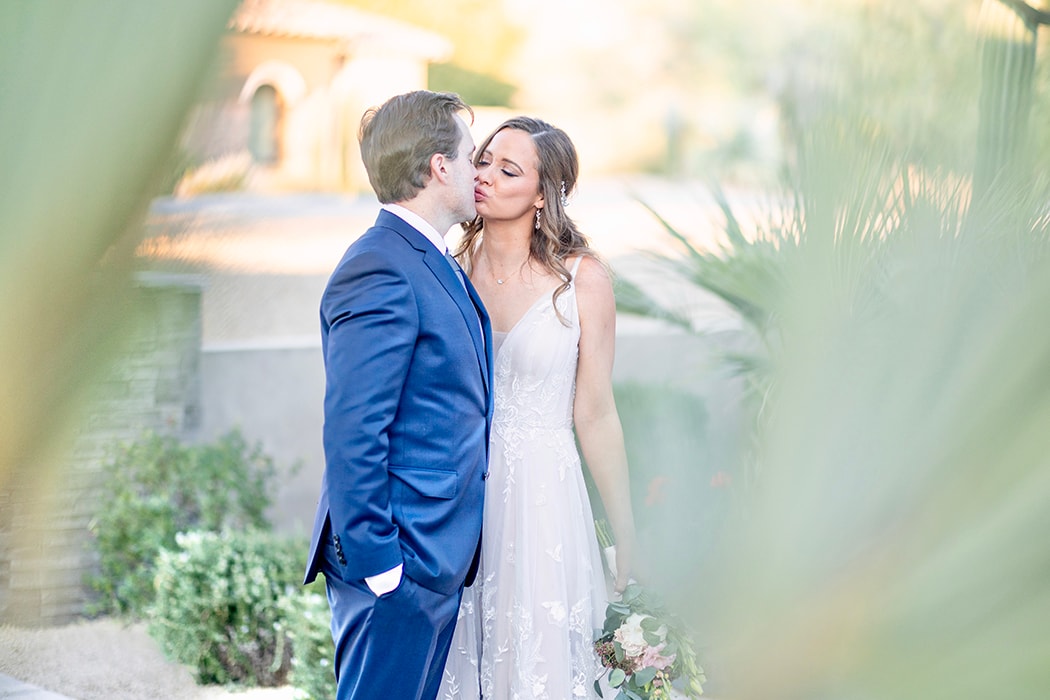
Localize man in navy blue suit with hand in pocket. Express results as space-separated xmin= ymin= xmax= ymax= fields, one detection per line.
xmin=306 ymin=90 xmax=492 ymax=700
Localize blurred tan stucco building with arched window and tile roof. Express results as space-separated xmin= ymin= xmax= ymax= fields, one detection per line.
xmin=183 ymin=0 xmax=453 ymax=192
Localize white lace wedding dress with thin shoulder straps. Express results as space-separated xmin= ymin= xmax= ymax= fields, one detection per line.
xmin=438 ymin=259 xmax=607 ymax=700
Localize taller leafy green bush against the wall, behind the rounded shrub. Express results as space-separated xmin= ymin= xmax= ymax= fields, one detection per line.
xmin=88 ymin=430 xmax=275 ymax=617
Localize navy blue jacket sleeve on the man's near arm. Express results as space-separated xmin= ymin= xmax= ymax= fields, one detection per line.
xmin=321 ymin=252 xmax=419 ymax=579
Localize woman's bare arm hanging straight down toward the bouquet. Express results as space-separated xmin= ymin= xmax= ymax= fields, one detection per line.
xmin=572 ymin=257 xmax=635 ymax=592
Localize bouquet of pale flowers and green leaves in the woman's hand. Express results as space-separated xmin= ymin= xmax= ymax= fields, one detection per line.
xmin=594 ymin=584 xmax=707 ymax=700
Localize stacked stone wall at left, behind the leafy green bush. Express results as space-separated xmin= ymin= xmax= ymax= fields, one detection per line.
xmin=0 ymin=273 xmax=202 ymax=625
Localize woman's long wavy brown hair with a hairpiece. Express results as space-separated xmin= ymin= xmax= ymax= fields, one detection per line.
xmin=456 ymin=116 xmax=597 ymax=320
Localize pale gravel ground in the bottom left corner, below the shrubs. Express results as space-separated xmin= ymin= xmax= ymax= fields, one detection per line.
xmin=0 ymin=619 xmax=294 ymax=700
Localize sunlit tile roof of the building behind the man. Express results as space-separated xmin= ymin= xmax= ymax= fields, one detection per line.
xmin=229 ymin=0 xmax=453 ymax=61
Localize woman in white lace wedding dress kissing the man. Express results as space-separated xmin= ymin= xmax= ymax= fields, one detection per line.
xmin=439 ymin=116 xmax=634 ymax=700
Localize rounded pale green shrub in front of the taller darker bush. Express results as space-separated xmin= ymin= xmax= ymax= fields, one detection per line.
xmin=149 ymin=530 xmax=307 ymax=686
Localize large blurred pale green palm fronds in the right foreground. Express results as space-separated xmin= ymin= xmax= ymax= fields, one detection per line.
xmin=622 ymin=4 xmax=1050 ymax=700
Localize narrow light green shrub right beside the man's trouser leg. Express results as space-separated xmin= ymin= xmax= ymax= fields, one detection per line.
xmin=282 ymin=579 xmax=335 ymax=700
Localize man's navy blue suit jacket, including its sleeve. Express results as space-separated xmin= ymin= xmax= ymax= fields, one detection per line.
xmin=306 ymin=211 xmax=492 ymax=594
